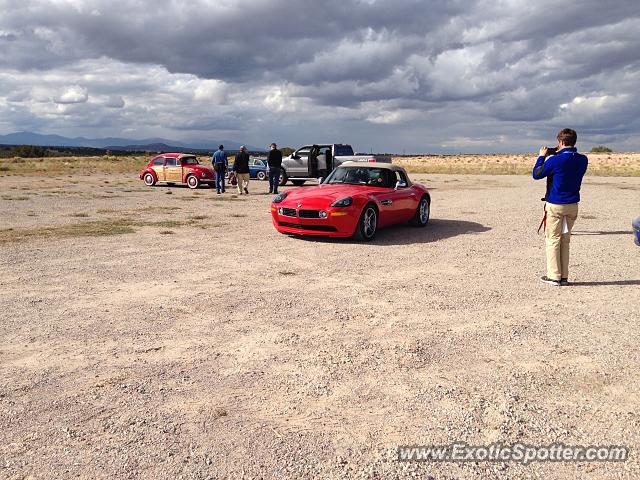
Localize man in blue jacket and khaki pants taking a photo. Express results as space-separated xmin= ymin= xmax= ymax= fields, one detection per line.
xmin=532 ymin=128 xmax=588 ymax=285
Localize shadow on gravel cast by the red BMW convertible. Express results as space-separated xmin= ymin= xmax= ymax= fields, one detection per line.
xmin=291 ymin=218 xmax=491 ymax=246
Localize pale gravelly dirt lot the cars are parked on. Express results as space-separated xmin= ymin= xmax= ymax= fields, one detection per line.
xmin=0 ymin=174 xmax=640 ymax=479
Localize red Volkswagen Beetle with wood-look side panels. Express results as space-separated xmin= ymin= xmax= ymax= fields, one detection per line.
xmin=140 ymin=153 xmax=215 ymax=188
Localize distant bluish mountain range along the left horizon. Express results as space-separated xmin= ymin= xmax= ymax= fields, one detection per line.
xmin=0 ymin=132 xmax=265 ymax=152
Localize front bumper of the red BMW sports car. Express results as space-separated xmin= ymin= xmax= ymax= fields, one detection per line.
xmin=271 ymin=203 xmax=359 ymax=238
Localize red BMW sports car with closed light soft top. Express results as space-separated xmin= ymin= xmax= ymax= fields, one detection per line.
xmin=271 ymin=162 xmax=431 ymax=241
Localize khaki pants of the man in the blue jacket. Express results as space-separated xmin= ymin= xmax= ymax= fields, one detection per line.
xmin=545 ymin=203 xmax=578 ymax=280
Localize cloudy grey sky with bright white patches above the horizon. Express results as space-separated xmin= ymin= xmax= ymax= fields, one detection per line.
xmin=0 ymin=0 xmax=640 ymax=153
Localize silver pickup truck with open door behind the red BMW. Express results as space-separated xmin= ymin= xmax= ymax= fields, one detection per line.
xmin=280 ymin=143 xmax=391 ymax=185
